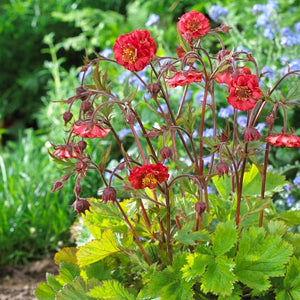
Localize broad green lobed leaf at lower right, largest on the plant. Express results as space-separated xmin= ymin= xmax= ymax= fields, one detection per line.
xmin=235 ymin=227 xmax=292 ymax=291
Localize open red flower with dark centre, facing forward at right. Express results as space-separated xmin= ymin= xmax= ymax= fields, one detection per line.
xmin=227 ymin=74 xmax=262 ymax=111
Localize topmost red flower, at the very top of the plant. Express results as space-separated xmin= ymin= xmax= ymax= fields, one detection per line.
xmin=177 ymin=10 xmax=209 ymax=42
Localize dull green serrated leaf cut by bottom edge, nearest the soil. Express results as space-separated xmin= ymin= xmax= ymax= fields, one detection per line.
xmin=55 ymin=277 xmax=91 ymax=300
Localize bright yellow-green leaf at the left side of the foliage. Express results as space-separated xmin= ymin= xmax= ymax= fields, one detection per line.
xmin=77 ymin=229 xmax=120 ymax=267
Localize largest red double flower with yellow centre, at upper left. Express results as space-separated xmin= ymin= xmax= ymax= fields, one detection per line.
xmin=113 ymin=30 xmax=156 ymax=71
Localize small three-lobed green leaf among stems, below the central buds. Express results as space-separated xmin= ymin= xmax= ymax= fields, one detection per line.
xmin=174 ymin=222 xmax=209 ymax=245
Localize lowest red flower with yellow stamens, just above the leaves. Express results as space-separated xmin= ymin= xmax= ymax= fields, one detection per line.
xmin=128 ymin=163 xmax=169 ymax=190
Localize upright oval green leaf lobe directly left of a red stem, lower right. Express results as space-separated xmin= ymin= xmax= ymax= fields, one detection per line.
xmin=212 ymin=220 xmax=237 ymax=256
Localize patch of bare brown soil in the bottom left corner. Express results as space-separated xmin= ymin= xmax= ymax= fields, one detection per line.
xmin=0 ymin=258 xmax=58 ymax=300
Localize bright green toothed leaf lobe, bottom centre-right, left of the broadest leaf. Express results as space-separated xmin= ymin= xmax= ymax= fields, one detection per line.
xmin=201 ymin=256 xmax=237 ymax=296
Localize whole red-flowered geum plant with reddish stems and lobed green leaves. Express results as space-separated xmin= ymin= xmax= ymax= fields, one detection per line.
xmin=35 ymin=11 xmax=300 ymax=300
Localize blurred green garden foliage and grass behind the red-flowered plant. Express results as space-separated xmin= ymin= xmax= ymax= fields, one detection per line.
xmin=0 ymin=0 xmax=300 ymax=265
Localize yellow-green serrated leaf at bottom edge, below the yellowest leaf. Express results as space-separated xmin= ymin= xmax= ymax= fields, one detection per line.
xmin=87 ymin=280 xmax=136 ymax=300
